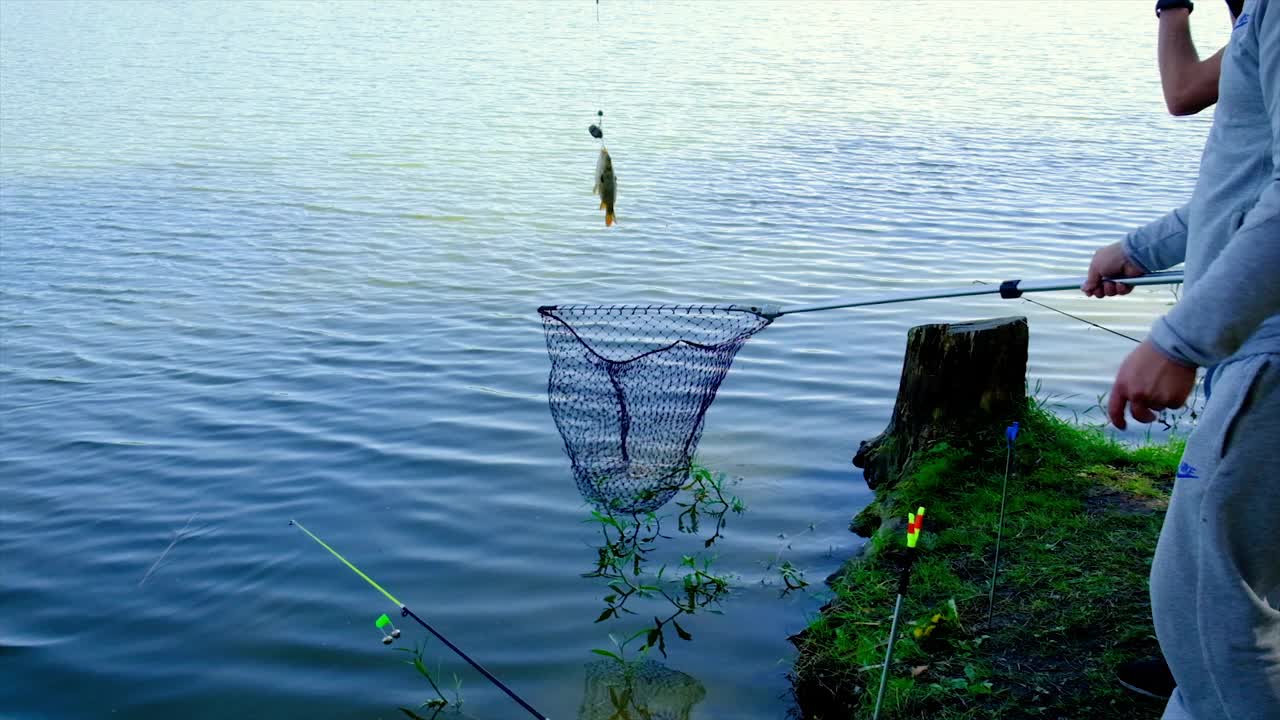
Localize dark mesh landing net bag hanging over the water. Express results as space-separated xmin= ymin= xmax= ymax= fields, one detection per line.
xmin=538 ymin=305 xmax=772 ymax=512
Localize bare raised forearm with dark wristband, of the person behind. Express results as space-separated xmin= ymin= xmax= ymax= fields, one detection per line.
xmin=1157 ymin=8 xmax=1226 ymax=115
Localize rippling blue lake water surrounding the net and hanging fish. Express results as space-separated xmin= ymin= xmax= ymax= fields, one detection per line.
xmin=0 ymin=0 xmax=1229 ymax=719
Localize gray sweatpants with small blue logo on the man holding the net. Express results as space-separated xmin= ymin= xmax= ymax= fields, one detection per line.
xmin=1151 ymin=355 xmax=1280 ymax=720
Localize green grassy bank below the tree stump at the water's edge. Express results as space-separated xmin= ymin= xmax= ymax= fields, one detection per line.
xmin=794 ymin=405 xmax=1181 ymax=720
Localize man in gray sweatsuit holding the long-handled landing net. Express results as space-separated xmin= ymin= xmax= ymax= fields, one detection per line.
xmin=1083 ymin=0 xmax=1280 ymax=720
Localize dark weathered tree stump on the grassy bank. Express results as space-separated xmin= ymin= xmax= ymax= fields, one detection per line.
xmin=854 ymin=318 xmax=1028 ymax=537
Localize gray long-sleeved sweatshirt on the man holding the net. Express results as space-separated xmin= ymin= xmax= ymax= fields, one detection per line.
xmin=1124 ymin=0 xmax=1280 ymax=366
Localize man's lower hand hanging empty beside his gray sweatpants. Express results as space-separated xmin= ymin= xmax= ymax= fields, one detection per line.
xmin=1107 ymin=340 xmax=1196 ymax=430
